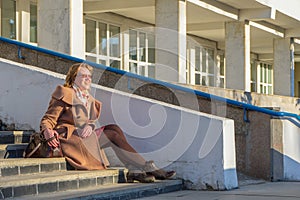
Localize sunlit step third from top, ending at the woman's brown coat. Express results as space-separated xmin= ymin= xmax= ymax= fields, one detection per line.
xmin=0 ymin=158 xmax=67 ymax=177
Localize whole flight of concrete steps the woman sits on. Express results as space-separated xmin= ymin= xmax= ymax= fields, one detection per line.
xmin=0 ymin=131 xmax=182 ymax=199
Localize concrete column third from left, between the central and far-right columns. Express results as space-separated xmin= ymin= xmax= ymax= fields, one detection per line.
xmin=225 ymin=22 xmax=251 ymax=92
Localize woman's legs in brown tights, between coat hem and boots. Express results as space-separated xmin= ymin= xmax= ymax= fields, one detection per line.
xmin=99 ymin=124 xmax=146 ymax=168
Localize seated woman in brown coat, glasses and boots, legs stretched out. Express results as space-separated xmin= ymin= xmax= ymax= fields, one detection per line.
xmin=40 ymin=63 xmax=175 ymax=182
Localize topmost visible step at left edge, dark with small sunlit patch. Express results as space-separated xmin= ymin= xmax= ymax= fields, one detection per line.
xmin=0 ymin=131 xmax=34 ymax=144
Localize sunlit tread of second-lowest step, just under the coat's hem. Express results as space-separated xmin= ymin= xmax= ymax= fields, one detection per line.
xmin=0 ymin=169 xmax=119 ymax=188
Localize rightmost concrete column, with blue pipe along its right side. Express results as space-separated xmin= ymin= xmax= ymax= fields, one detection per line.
xmin=273 ymin=38 xmax=294 ymax=96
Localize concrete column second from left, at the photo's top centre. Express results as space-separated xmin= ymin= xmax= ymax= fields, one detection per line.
xmin=155 ymin=0 xmax=186 ymax=83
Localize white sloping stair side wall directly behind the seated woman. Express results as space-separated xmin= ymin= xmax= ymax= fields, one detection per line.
xmin=0 ymin=59 xmax=238 ymax=190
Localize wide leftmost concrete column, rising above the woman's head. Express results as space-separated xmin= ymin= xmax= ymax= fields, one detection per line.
xmin=38 ymin=0 xmax=85 ymax=58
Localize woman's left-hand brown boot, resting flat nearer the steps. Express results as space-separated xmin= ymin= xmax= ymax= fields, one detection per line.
xmin=126 ymin=169 xmax=155 ymax=183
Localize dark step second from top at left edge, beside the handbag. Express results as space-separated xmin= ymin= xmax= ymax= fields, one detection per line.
xmin=0 ymin=143 xmax=27 ymax=158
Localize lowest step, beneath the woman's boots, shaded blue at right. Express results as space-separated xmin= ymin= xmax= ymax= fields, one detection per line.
xmin=15 ymin=180 xmax=183 ymax=200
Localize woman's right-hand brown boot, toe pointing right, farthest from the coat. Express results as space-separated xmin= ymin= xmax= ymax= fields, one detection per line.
xmin=144 ymin=160 xmax=176 ymax=180
